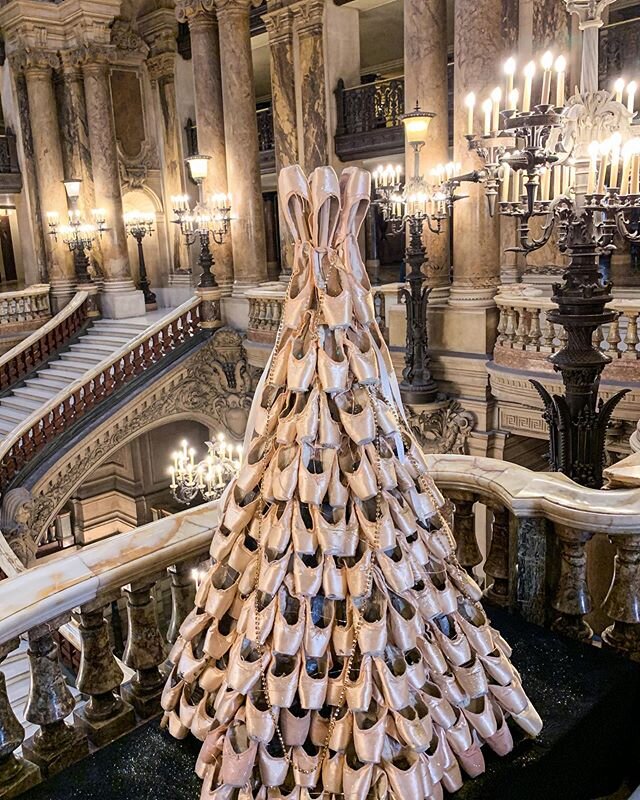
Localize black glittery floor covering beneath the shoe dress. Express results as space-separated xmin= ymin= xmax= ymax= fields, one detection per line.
xmin=22 ymin=609 xmax=640 ymax=800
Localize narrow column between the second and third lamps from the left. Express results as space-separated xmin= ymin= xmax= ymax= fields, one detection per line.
xmin=147 ymin=48 xmax=191 ymax=286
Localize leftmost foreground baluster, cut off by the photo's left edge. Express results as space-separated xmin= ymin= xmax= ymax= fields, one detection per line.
xmin=0 ymin=639 xmax=41 ymax=800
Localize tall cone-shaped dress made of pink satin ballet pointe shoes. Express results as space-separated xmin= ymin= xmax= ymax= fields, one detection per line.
xmin=163 ymin=167 xmax=541 ymax=800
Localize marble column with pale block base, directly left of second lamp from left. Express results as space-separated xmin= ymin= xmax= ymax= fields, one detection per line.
xmin=82 ymin=45 xmax=145 ymax=318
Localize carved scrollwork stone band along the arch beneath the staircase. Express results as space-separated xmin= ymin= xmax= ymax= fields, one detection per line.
xmin=25 ymin=328 xmax=260 ymax=537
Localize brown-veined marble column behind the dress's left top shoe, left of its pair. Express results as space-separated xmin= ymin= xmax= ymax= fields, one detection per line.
xmin=262 ymin=8 xmax=298 ymax=276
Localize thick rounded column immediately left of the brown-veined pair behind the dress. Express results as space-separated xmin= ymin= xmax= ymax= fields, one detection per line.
xmin=215 ymin=0 xmax=267 ymax=294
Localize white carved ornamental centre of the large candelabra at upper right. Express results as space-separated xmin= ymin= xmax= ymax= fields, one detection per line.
xmin=563 ymin=89 xmax=633 ymax=158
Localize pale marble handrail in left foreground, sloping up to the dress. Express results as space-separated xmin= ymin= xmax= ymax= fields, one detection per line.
xmin=0 ymin=500 xmax=219 ymax=645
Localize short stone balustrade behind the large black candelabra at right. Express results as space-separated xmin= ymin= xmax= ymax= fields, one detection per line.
xmin=494 ymin=289 xmax=640 ymax=380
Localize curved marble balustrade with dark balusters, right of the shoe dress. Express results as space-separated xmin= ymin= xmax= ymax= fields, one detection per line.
xmin=427 ymin=455 xmax=640 ymax=659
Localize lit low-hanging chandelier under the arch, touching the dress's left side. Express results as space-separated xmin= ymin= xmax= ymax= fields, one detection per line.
xmin=169 ymin=433 xmax=242 ymax=505
